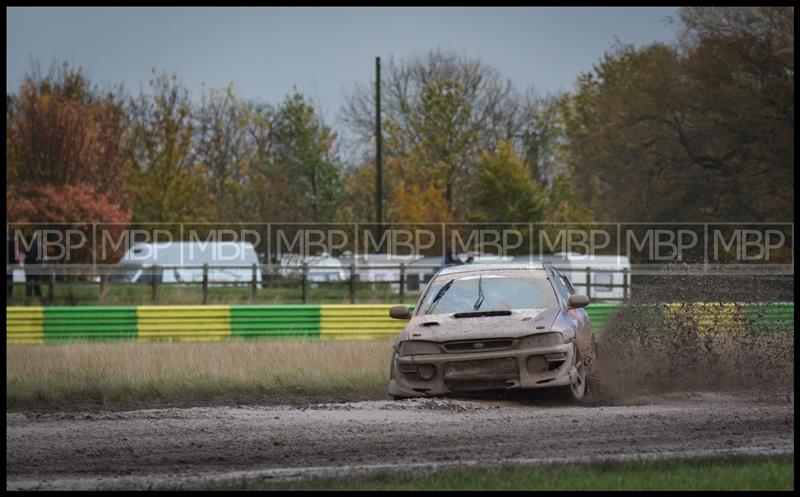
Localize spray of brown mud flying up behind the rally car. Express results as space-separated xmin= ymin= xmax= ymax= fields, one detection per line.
xmin=590 ymin=275 xmax=794 ymax=403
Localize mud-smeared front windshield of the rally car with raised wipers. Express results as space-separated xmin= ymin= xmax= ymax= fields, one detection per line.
xmin=420 ymin=270 xmax=558 ymax=314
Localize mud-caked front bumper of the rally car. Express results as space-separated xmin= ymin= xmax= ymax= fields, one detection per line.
xmin=389 ymin=342 xmax=578 ymax=397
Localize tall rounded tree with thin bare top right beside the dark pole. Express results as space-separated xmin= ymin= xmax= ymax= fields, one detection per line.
xmin=343 ymin=50 xmax=521 ymax=216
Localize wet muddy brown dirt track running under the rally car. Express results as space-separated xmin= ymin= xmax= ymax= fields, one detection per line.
xmin=6 ymin=391 xmax=794 ymax=489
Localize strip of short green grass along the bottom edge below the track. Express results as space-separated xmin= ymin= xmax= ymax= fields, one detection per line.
xmin=184 ymin=455 xmax=794 ymax=490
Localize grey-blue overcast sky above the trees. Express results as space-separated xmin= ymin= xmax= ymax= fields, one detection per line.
xmin=6 ymin=7 xmax=677 ymax=119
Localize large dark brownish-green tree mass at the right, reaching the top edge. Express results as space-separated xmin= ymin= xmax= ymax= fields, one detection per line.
xmin=563 ymin=7 xmax=794 ymax=222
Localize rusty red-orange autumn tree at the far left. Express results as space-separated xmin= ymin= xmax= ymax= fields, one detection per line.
xmin=6 ymin=64 xmax=131 ymax=262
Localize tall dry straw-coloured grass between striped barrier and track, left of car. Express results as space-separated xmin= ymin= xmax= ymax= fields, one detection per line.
xmin=6 ymin=340 xmax=391 ymax=409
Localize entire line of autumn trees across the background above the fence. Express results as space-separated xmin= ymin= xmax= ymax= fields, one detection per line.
xmin=6 ymin=7 xmax=794 ymax=227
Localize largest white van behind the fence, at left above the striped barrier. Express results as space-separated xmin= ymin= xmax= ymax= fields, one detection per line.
xmin=109 ymin=241 xmax=261 ymax=288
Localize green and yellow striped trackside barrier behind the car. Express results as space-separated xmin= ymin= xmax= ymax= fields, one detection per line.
xmin=6 ymin=302 xmax=794 ymax=343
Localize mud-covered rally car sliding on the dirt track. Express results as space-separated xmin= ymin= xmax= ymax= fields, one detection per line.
xmin=389 ymin=264 xmax=595 ymax=401
